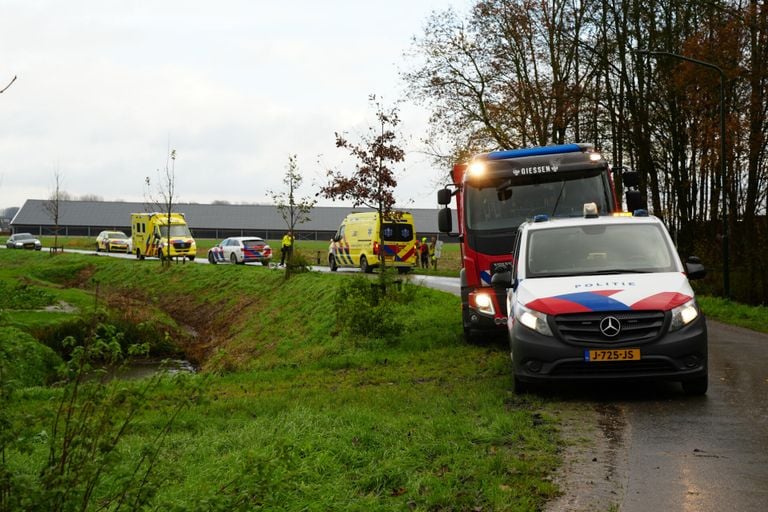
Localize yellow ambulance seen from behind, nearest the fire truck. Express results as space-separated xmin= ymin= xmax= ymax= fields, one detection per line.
xmin=328 ymin=212 xmax=418 ymax=274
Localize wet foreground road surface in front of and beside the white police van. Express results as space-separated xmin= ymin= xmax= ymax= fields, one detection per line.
xmin=620 ymin=321 xmax=768 ymax=512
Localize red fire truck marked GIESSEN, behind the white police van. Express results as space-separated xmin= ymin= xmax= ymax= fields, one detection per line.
xmin=437 ymin=144 xmax=641 ymax=342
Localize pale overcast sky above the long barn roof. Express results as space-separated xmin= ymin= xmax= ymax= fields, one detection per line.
xmin=0 ymin=0 xmax=467 ymax=209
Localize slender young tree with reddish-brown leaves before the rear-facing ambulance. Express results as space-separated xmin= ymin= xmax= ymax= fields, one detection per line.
xmin=320 ymin=94 xmax=405 ymax=268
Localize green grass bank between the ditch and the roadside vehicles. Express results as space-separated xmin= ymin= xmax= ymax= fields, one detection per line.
xmin=0 ymin=251 xmax=558 ymax=510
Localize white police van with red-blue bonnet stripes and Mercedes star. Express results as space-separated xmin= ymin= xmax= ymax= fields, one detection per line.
xmin=489 ymin=204 xmax=708 ymax=395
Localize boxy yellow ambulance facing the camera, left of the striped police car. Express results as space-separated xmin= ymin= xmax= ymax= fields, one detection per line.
xmin=131 ymin=212 xmax=197 ymax=261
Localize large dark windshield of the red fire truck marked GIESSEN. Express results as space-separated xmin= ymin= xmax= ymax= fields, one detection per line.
xmin=464 ymin=168 xmax=612 ymax=231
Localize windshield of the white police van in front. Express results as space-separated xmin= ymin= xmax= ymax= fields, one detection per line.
xmin=526 ymin=224 xmax=678 ymax=277
